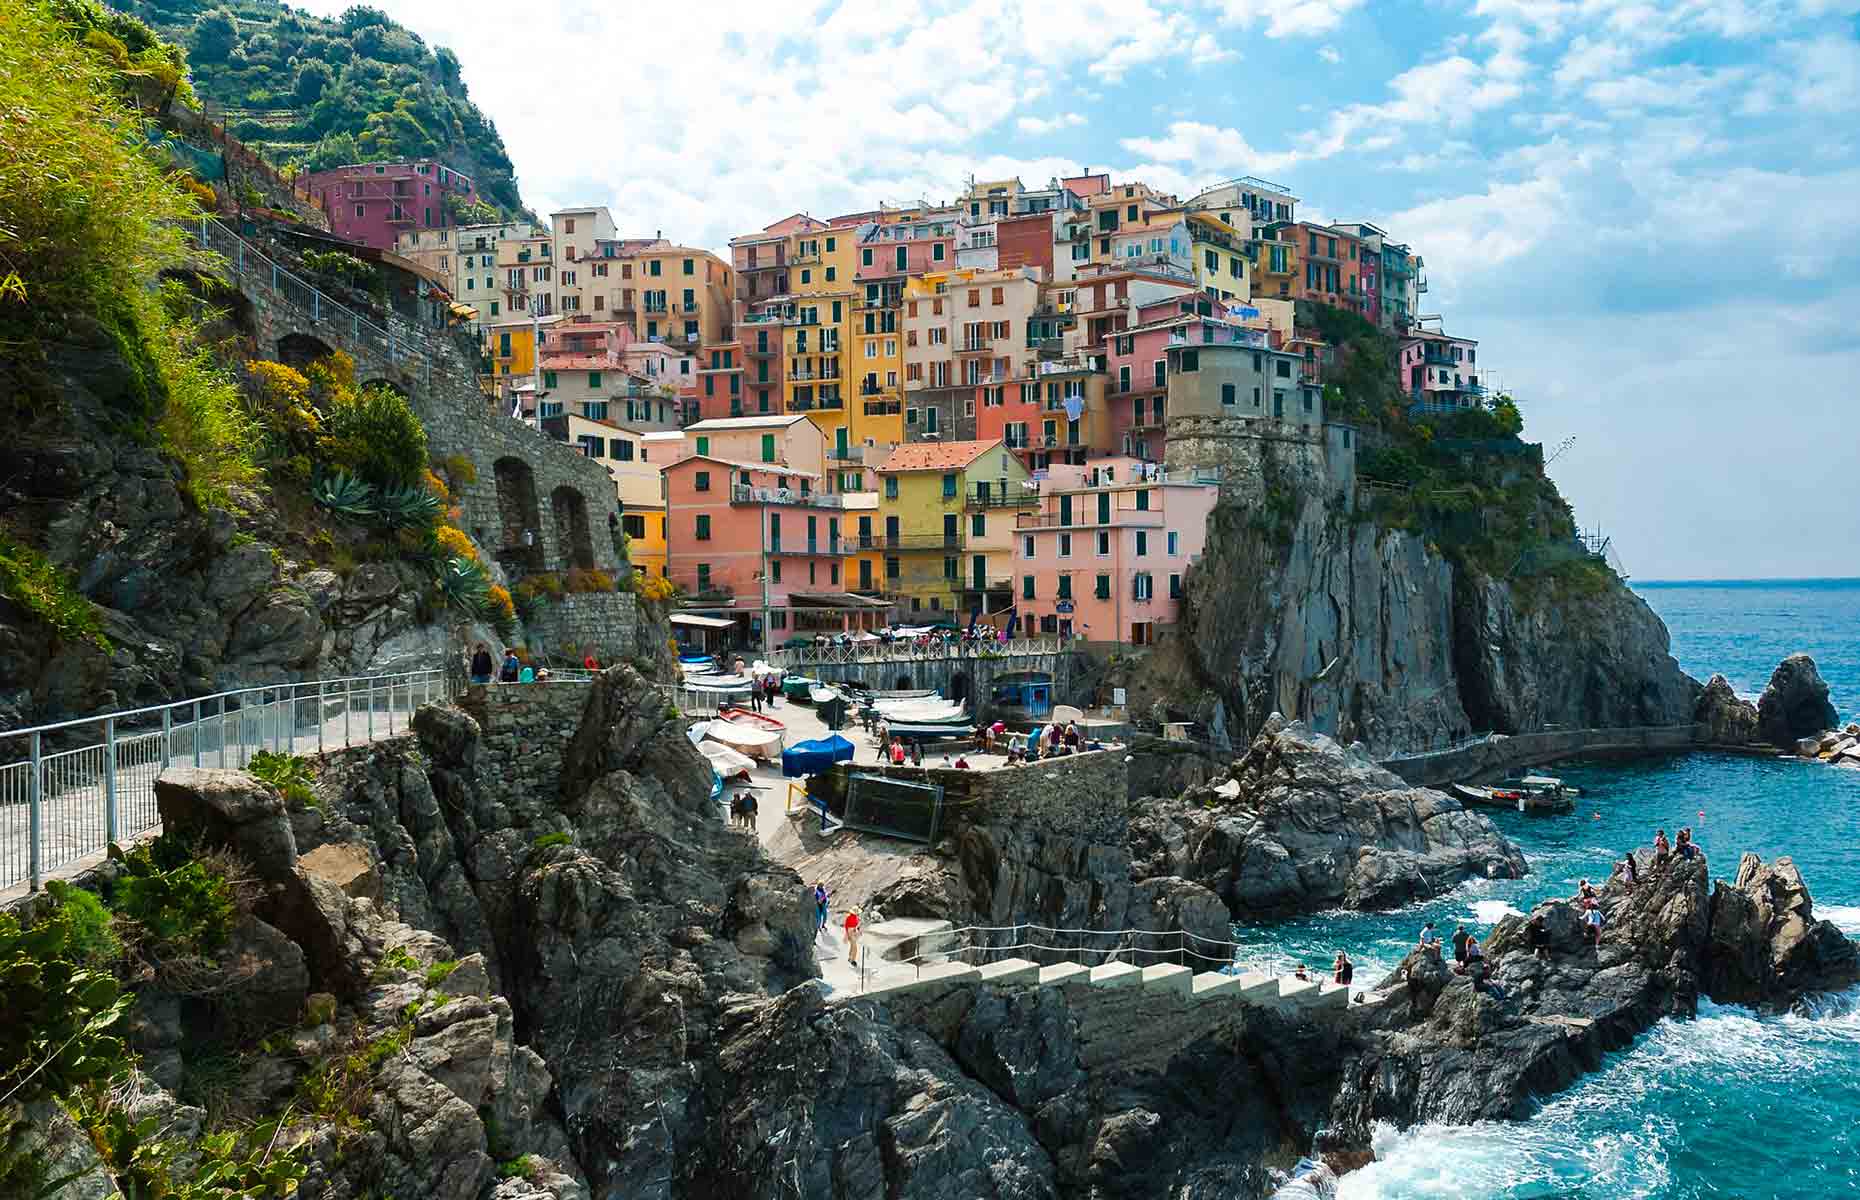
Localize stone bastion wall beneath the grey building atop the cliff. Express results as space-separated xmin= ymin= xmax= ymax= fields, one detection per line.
xmin=1164 ymin=417 xmax=1356 ymax=497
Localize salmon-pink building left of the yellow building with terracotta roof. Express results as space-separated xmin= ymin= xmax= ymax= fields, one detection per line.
xmin=664 ymin=454 xmax=889 ymax=649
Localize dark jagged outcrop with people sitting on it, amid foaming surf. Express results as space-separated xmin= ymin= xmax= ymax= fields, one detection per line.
xmin=1334 ymin=852 xmax=1856 ymax=1140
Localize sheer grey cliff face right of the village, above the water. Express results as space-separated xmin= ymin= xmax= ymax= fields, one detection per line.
xmin=1157 ymin=483 xmax=1700 ymax=753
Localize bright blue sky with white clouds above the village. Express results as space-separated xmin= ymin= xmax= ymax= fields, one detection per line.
xmin=301 ymin=0 xmax=1860 ymax=579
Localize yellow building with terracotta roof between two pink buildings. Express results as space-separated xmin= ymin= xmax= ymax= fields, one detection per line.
xmin=878 ymin=439 xmax=1029 ymax=621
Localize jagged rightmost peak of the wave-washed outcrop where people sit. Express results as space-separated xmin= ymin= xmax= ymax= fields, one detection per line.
xmin=1706 ymin=854 xmax=1860 ymax=1008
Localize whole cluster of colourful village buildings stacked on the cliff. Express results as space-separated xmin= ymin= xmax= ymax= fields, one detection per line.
xmin=301 ymin=162 xmax=1488 ymax=647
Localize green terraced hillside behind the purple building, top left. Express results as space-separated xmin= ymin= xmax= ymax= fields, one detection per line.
xmin=115 ymin=0 xmax=523 ymax=220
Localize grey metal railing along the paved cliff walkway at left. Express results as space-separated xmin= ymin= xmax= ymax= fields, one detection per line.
xmin=0 ymin=670 xmax=461 ymax=891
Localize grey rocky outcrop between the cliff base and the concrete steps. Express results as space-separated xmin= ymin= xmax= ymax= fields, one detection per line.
xmin=1129 ymin=722 xmax=1525 ymax=919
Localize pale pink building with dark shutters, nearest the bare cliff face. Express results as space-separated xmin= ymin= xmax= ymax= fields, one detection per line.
xmin=1014 ymin=458 xmax=1220 ymax=646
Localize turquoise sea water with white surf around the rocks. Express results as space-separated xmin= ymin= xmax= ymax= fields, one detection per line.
xmin=1239 ymin=579 xmax=1860 ymax=1200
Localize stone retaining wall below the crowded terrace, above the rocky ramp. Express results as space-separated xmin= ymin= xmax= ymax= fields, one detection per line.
xmin=815 ymin=746 xmax=1129 ymax=847
